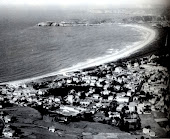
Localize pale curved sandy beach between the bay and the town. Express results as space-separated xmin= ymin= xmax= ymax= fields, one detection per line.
xmin=0 ymin=24 xmax=156 ymax=85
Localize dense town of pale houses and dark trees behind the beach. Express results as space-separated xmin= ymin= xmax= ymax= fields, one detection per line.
xmin=0 ymin=51 xmax=170 ymax=138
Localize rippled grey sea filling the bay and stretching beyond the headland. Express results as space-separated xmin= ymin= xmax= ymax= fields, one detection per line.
xmin=0 ymin=6 xmax=144 ymax=82
